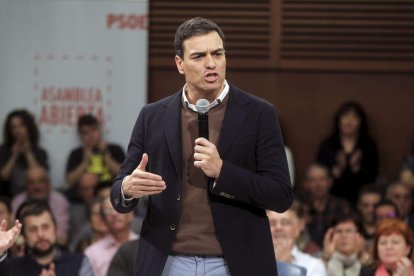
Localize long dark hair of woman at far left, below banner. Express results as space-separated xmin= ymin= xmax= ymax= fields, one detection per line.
xmin=3 ymin=109 xmax=39 ymax=147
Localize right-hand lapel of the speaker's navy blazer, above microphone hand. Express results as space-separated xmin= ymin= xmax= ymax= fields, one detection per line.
xmin=217 ymin=85 xmax=248 ymax=157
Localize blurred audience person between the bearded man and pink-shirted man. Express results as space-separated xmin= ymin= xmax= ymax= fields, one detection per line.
xmin=69 ymin=197 xmax=108 ymax=252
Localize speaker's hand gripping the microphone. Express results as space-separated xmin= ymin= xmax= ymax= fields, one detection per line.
xmin=194 ymin=138 xmax=223 ymax=178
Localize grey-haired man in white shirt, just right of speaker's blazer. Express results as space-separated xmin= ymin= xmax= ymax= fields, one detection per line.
xmin=267 ymin=201 xmax=326 ymax=276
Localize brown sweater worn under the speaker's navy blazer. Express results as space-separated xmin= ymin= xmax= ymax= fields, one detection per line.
xmin=172 ymin=97 xmax=228 ymax=255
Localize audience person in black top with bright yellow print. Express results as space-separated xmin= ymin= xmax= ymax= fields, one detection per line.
xmin=66 ymin=115 xmax=125 ymax=188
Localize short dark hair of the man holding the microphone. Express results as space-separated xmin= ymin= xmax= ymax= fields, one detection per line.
xmin=174 ymin=17 xmax=224 ymax=58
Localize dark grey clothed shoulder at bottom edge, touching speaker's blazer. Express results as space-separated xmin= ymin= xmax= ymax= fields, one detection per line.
xmin=107 ymin=239 xmax=139 ymax=276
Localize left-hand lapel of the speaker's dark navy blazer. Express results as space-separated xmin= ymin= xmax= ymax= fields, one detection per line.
xmin=163 ymin=92 xmax=182 ymax=175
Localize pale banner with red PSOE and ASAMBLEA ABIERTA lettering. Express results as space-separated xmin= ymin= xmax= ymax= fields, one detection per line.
xmin=0 ymin=0 xmax=148 ymax=190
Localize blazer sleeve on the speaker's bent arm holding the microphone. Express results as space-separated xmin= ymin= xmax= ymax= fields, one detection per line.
xmin=212 ymin=103 xmax=293 ymax=212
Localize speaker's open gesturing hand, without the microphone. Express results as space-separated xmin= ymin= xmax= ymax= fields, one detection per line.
xmin=122 ymin=153 xmax=166 ymax=198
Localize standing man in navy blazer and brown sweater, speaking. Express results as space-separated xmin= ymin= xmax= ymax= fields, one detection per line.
xmin=111 ymin=17 xmax=293 ymax=276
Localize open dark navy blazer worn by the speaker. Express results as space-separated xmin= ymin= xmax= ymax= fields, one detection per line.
xmin=111 ymin=84 xmax=293 ymax=276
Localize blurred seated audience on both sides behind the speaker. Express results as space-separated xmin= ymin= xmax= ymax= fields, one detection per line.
xmin=0 ymin=101 xmax=414 ymax=276
